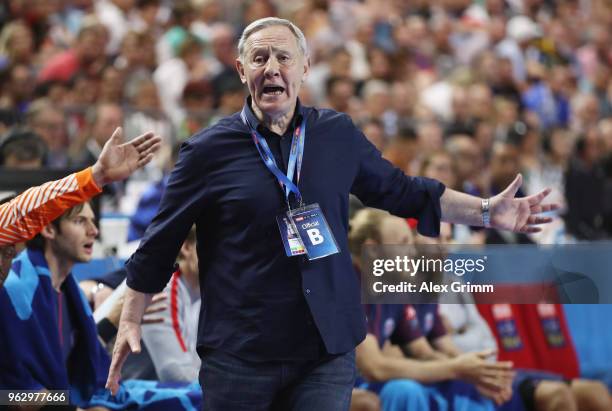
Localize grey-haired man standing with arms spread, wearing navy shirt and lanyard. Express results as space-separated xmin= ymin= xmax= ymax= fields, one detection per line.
xmin=107 ymin=18 xmax=554 ymax=411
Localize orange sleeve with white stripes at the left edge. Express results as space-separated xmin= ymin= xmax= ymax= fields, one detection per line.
xmin=0 ymin=167 xmax=102 ymax=246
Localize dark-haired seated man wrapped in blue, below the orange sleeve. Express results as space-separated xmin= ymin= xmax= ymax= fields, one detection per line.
xmin=0 ymin=203 xmax=201 ymax=410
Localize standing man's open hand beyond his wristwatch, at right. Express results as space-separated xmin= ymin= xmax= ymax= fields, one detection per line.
xmin=490 ymin=174 xmax=559 ymax=233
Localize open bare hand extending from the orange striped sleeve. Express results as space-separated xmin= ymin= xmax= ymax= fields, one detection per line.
xmin=92 ymin=127 xmax=161 ymax=187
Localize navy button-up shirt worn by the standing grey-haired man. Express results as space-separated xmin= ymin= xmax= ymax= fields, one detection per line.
xmin=126 ymin=99 xmax=444 ymax=361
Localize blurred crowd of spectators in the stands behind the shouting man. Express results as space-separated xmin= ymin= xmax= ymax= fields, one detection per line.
xmin=0 ymin=0 xmax=612 ymax=243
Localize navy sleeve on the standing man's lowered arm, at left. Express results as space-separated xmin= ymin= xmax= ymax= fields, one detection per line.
xmin=126 ymin=139 xmax=206 ymax=293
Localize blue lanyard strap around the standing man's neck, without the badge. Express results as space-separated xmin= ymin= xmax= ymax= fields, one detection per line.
xmin=240 ymin=108 xmax=306 ymax=205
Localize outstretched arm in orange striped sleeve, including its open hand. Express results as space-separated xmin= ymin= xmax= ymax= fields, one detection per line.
xmin=0 ymin=128 xmax=161 ymax=286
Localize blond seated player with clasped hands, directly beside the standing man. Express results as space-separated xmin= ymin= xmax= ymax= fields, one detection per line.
xmin=349 ymin=209 xmax=513 ymax=410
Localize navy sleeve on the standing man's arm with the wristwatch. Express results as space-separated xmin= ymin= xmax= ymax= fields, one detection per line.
xmin=349 ymin=120 xmax=445 ymax=237
